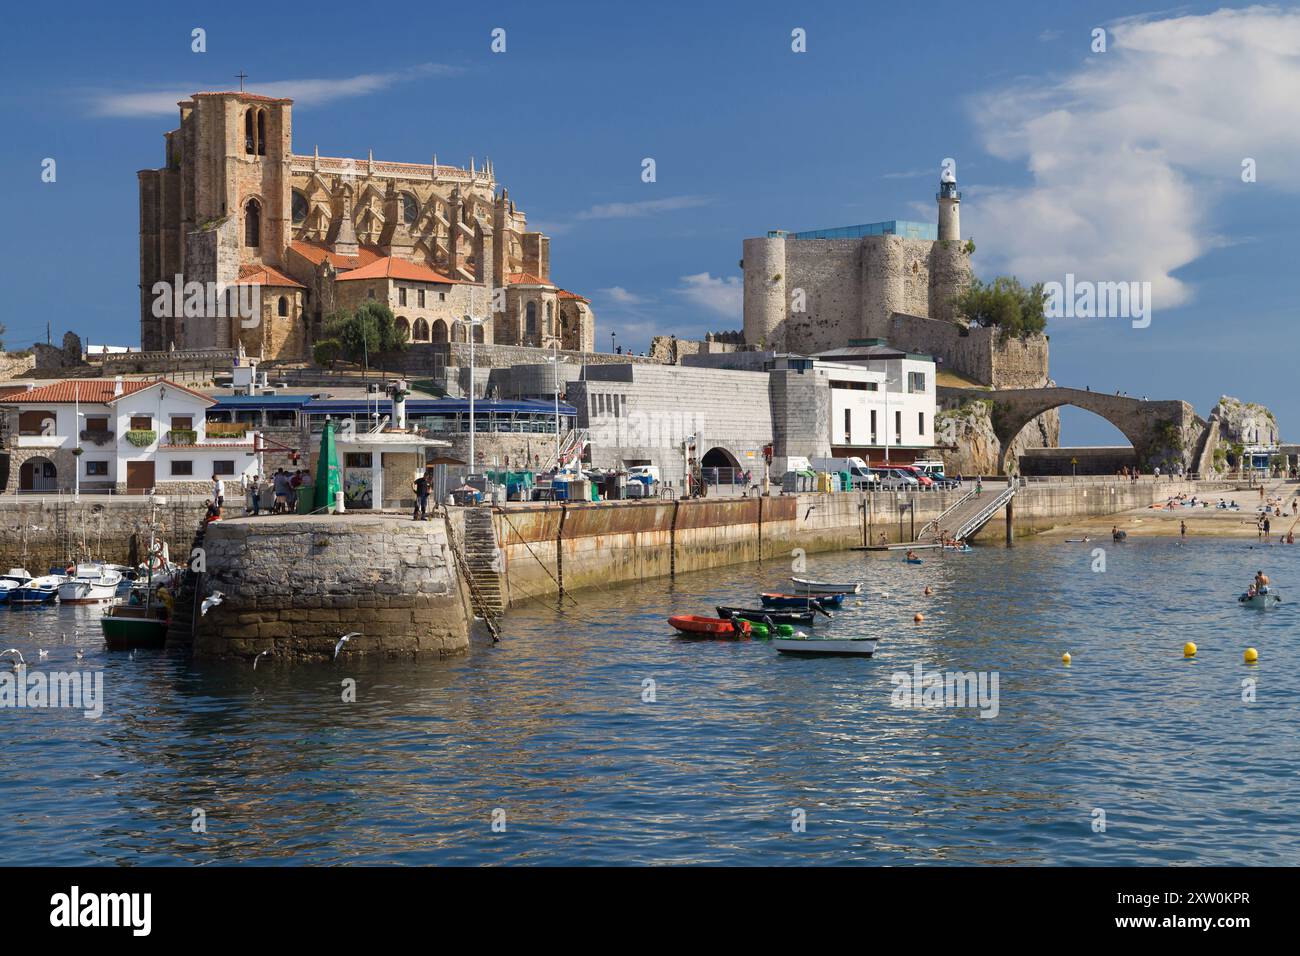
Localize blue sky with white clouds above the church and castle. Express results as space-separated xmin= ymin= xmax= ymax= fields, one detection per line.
xmin=0 ymin=1 xmax=1300 ymax=442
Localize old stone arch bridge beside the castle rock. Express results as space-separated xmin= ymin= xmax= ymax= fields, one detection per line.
xmin=939 ymin=386 xmax=1218 ymax=475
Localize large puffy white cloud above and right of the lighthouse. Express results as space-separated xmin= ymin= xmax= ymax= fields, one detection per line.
xmin=966 ymin=7 xmax=1300 ymax=308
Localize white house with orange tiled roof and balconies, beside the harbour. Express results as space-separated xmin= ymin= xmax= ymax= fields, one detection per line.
xmin=0 ymin=378 xmax=256 ymax=494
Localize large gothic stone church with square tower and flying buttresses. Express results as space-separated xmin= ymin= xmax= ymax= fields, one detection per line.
xmin=139 ymin=92 xmax=595 ymax=362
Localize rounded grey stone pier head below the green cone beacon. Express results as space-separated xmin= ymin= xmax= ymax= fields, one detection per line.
xmin=194 ymin=514 xmax=469 ymax=661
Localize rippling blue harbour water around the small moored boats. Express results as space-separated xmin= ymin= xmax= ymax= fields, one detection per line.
xmin=0 ymin=540 xmax=1300 ymax=865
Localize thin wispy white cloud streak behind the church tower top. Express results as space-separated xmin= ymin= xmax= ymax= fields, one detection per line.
xmin=90 ymin=64 xmax=459 ymax=118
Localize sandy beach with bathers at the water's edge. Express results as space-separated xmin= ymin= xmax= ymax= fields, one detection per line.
xmin=1039 ymin=479 xmax=1300 ymax=544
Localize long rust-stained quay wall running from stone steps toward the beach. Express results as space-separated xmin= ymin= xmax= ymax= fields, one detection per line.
xmin=494 ymin=480 xmax=1231 ymax=604
